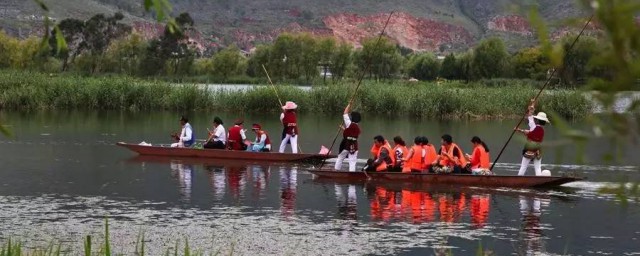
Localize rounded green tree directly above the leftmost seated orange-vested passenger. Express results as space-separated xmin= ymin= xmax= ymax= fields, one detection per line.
xmin=355 ymin=37 xmax=403 ymax=79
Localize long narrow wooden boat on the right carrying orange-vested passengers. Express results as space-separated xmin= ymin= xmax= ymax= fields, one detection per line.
xmin=309 ymin=170 xmax=583 ymax=188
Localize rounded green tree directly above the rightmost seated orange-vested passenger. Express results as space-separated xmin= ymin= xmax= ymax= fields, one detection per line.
xmin=471 ymin=38 xmax=508 ymax=79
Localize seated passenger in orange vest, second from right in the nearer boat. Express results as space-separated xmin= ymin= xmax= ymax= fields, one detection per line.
xmin=431 ymin=134 xmax=469 ymax=173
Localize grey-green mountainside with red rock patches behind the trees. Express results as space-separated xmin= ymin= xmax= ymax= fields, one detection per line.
xmin=0 ymin=0 xmax=585 ymax=52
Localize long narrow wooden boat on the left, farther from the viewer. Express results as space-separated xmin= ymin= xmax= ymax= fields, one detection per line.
xmin=116 ymin=142 xmax=336 ymax=162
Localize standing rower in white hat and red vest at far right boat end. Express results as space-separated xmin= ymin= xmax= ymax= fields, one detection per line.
xmin=514 ymin=100 xmax=549 ymax=176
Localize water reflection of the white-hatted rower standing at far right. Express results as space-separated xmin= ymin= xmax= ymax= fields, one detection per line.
xmin=518 ymin=196 xmax=544 ymax=255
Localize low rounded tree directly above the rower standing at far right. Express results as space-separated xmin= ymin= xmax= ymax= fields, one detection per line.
xmin=511 ymin=47 xmax=550 ymax=80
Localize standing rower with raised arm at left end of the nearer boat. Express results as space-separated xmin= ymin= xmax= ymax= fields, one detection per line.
xmin=334 ymin=105 xmax=361 ymax=172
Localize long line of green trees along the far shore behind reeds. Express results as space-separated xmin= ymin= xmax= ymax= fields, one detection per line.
xmin=0 ymin=13 xmax=611 ymax=85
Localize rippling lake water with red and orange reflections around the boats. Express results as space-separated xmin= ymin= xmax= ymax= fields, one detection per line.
xmin=0 ymin=112 xmax=640 ymax=255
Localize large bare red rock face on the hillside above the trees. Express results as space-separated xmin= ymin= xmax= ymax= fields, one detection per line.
xmin=323 ymin=13 xmax=473 ymax=51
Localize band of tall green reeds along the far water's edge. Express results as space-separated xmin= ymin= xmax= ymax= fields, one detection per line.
xmin=0 ymin=71 xmax=592 ymax=119
